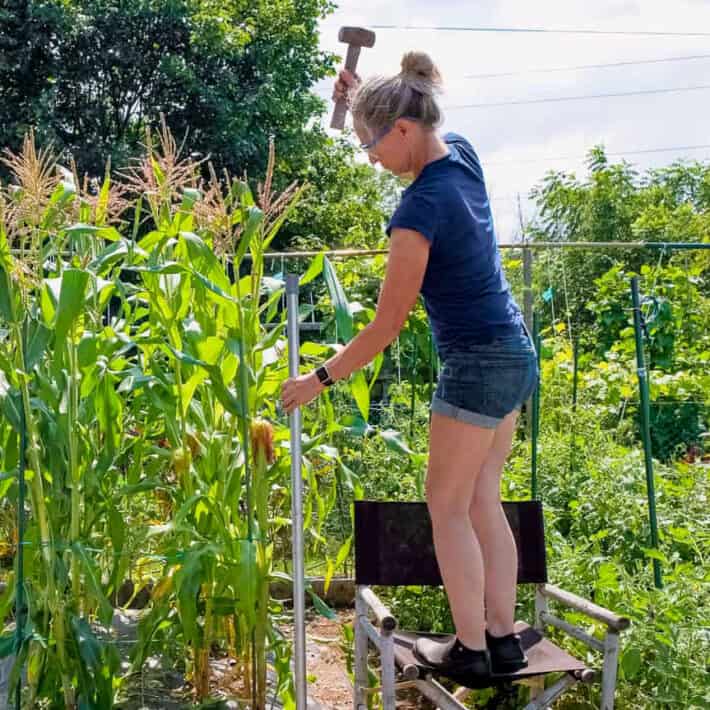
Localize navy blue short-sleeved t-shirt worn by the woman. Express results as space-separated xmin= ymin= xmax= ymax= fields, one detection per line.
xmin=387 ymin=133 xmax=522 ymax=356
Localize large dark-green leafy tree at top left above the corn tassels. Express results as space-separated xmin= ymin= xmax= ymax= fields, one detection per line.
xmin=0 ymin=0 xmax=334 ymax=175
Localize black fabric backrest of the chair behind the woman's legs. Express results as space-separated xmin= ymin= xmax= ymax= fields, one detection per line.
xmin=355 ymin=501 xmax=547 ymax=586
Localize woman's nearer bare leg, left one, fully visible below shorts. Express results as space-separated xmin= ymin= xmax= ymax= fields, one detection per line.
xmin=426 ymin=413 xmax=495 ymax=649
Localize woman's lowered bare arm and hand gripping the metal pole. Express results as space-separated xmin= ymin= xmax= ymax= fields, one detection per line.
xmin=281 ymin=229 xmax=429 ymax=412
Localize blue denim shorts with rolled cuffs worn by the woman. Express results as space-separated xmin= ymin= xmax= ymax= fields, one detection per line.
xmin=431 ymin=327 xmax=538 ymax=429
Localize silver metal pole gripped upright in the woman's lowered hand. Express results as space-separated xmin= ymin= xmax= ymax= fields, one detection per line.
xmin=286 ymin=274 xmax=308 ymax=710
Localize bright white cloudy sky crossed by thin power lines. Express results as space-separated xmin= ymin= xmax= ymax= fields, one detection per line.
xmin=315 ymin=0 xmax=710 ymax=243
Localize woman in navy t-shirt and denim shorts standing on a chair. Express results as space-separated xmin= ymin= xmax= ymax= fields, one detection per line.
xmin=282 ymin=52 xmax=537 ymax=677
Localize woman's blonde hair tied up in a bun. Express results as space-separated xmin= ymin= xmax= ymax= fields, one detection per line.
xmin=350 ymin=52 xmax=443 ymax=133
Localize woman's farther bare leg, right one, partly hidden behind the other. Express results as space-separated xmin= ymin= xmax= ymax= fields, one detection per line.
xmin=469 ymin=412 xmax=518 ymax=636
